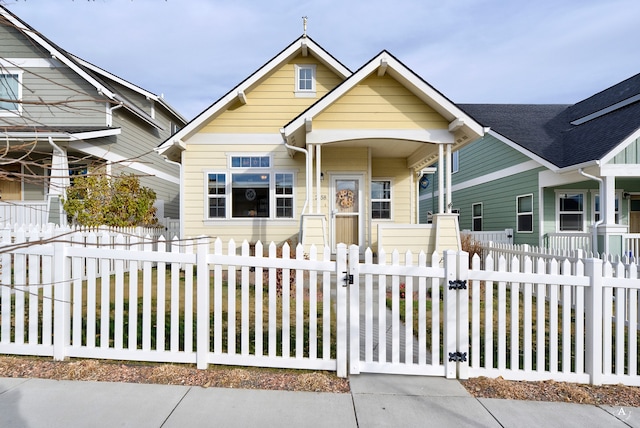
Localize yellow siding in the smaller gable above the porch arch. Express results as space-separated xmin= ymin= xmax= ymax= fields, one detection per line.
xmin=313 ymin=74 xmax=448 ymax=129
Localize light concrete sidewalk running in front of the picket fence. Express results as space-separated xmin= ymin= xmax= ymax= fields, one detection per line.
xmin=0 ymin=374 xmax=640 ymax=428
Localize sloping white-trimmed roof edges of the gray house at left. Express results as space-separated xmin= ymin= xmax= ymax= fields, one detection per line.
xmin=0 ymin=6 xmax=182 ymax=129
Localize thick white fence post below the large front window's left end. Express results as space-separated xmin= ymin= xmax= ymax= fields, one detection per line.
xmin=196 ymin=237 xmax=210 ymax=370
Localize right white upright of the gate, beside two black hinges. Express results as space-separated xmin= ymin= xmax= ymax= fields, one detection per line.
xmin=442 ymin=250 xmax=458 ymax=379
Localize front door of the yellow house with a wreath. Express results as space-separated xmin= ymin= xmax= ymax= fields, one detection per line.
xmin=331 ymin=175 xmax=362 ymax=251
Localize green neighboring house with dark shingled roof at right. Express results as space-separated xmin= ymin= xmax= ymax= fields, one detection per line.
xmin=420 ymin=74 xmax=640 ymax=256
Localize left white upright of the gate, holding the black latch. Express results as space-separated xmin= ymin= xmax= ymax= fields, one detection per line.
xmin=350 ymin=245 xmax=360 ymax=374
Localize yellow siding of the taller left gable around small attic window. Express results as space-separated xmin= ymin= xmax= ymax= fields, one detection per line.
xmin=202 ymin=56 xmax=341 ymax=133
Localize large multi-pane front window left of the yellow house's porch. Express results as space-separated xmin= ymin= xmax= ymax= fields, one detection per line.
xmin=207 ymin=155 xmax=294 ymax=219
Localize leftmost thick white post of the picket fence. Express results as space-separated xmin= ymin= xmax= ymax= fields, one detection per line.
xmin=53 ymin=242 xmax=71 ymax=361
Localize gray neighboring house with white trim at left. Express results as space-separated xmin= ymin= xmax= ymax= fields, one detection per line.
xmin=0 ymin=6 xmax=186 ymax=224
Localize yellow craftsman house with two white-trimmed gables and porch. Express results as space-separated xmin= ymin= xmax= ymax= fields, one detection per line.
xmin=158 ymin=35 xmax=484 ymax=251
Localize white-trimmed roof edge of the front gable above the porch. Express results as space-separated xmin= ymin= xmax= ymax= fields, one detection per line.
xmin=283 ymin=50 xmax=484 ymax=145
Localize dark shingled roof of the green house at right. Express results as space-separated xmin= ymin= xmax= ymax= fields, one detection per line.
xmin=459 ymin=74 xmax=640 ymax=169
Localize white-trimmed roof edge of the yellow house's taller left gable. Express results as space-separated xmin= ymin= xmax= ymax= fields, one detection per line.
xmin=156 ymin=35 xmax=351 ymax=160
